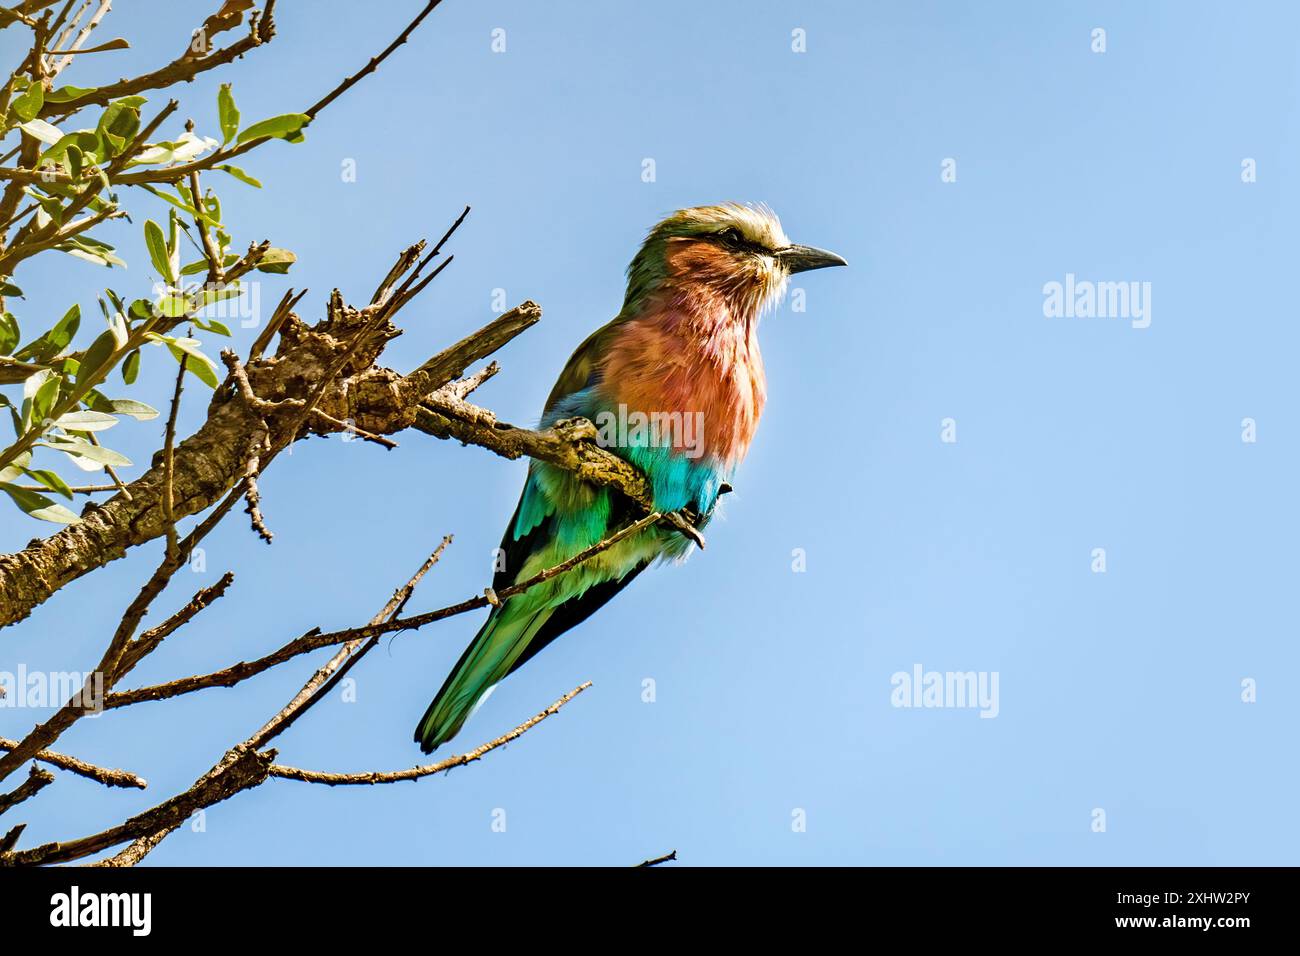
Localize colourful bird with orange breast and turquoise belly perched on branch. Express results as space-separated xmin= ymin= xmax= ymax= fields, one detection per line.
xmin=415 ymin=202 xmax=848 ymax=753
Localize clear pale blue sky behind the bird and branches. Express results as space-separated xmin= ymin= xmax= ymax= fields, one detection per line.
xmin=0 ymin=0 xmax=1300 ymax=865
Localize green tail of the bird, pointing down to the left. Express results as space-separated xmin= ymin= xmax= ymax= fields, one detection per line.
xmin=415 ymin=601 xmax=550 ymax=753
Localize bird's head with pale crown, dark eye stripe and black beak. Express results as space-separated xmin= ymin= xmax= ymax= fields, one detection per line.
xmin=624 ymin=203 xmax=848 ymax=319
